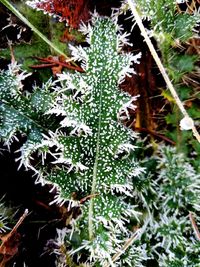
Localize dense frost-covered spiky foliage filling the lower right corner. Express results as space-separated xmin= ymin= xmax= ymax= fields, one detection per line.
xmin=53 ymin=145 xmax=200 ymax=267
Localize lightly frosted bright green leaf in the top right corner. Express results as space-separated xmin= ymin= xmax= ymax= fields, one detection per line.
xmin=136 ymin=0 xmax=199 ymax=44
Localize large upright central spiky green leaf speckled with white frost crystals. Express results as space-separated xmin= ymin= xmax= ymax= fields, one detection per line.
xmin=42 ymin=16 xmax=144 ymax=263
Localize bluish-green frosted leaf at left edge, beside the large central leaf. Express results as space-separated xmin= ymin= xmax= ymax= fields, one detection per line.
xmin=0 ymin=63 xmax=55 ymax=170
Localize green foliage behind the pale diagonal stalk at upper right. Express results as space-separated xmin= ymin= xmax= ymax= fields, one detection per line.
xmin=136 ymin=0 xmax=200 ymax=161
